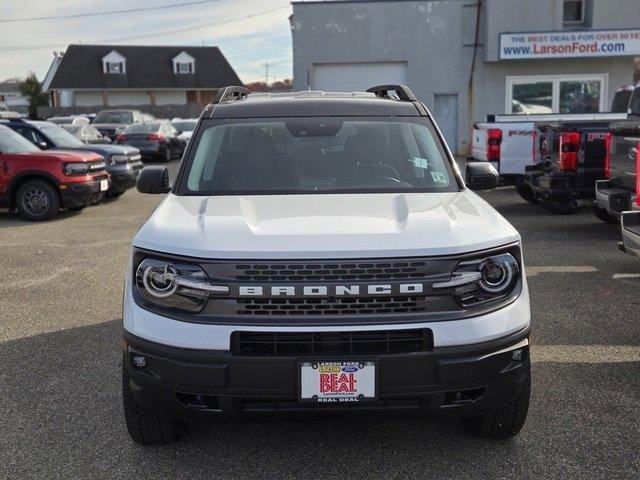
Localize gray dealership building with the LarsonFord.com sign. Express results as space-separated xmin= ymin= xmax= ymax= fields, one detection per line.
xmin=291 ymin=0 xmax=640 ymax=154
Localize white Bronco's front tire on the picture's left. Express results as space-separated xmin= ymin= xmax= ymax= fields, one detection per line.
xmin=122 ymin=366 xmax=187 ymax=445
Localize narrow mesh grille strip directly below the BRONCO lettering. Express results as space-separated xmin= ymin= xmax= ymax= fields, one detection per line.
xmin=236 ymin=296 xmax=427 ymax=315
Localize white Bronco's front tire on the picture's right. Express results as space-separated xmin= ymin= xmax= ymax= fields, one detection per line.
xmin=462 ymin=367 xmax=531 ymax=439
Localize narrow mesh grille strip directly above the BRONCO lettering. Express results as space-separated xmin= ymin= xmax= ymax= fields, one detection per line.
xmin=236 ymin=260 xmax=427 ymax=281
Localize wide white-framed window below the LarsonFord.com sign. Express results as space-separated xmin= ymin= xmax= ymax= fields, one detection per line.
xmin=506 ymin=74 xmax=608 ymax=115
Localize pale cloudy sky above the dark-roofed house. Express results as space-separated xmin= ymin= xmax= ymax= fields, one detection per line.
xmin=0 ymin=0 xmax=292 ymax=82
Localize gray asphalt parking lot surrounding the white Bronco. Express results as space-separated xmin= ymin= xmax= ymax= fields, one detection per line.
xmin=0 ymin=171 xmax=640 ymax=479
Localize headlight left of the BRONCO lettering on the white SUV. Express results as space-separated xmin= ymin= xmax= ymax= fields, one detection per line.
xmin=136 ymin=258 xmax=229 ymax=313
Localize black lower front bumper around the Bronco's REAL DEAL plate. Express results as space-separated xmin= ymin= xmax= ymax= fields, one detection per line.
xmin=123 ymin=328 xmax=530 ymax=421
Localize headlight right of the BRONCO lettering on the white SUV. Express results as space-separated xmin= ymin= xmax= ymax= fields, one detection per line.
xmin=433 ymin=253 xmax=520 ymax=307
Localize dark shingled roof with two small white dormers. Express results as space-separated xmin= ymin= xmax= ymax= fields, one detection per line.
xmin=50 ymin=45 xmax=242 ymax=90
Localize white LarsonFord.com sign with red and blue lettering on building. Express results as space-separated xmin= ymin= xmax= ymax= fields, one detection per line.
xmin=500 ymin=28 xmax=640 ymax=60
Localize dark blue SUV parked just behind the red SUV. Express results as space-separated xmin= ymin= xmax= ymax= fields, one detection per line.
xmin=4 ymin=120 xmax=143 ymax=197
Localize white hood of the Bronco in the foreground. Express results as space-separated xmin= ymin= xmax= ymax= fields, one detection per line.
xmin=133 ymin=190 xmax=520 ymax=259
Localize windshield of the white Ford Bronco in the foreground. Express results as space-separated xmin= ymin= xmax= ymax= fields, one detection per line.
xmin=178 ymin=117 xmax=458 ymax=195
